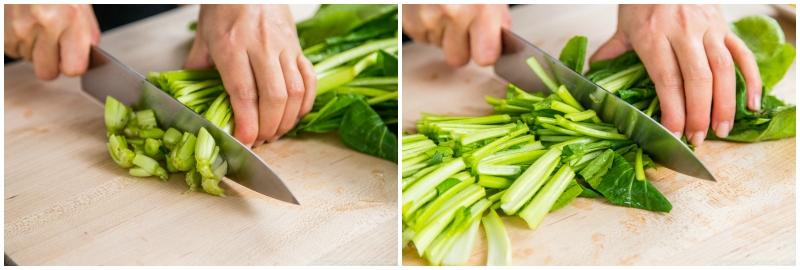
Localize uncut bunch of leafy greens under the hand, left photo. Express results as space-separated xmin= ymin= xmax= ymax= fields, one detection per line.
xmin=147 ymin=4 xmax=398 ymax=162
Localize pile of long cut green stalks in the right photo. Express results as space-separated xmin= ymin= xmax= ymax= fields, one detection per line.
xmin=402 ymin=70 xmax=672 ymax=265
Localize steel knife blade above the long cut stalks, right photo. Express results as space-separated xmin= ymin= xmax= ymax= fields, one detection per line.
xmin=494 ymin=30 xmax=716 ymax=181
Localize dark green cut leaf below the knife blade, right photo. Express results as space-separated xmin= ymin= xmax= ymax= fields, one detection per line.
xmin=596 ymin=154 xmax=672 ymax=213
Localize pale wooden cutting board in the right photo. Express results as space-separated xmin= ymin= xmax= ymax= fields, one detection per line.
xmin=402 ymin=5 xmax=797 ymax=265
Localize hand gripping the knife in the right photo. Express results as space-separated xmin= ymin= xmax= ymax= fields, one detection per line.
xmin=403 ymin=5 xmax=511 ymax=67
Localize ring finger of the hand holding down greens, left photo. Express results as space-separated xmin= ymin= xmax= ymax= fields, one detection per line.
xmin=269 ymin=53 xmax=305 ymax=142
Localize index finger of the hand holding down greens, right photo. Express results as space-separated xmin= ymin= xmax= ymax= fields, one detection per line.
xmin=632 ymin=36 xmax=686 ymax=138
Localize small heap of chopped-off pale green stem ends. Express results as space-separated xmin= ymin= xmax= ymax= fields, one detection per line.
xmin=105 ymin=96 xmax=228 ymax=197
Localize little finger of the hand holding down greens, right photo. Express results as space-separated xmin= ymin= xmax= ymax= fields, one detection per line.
xmin=725 ymin=32 xmax=762 ymax=111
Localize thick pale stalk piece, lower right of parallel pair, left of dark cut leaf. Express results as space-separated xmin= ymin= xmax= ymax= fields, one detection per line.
xmin=519 ymin=164 xmax=575 ymax=230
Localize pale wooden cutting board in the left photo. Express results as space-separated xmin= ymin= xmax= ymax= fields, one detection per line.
xmin=3 ymin=6 xmax=398 ymax=265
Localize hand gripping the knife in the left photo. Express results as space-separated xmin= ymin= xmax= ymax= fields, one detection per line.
xmin=3 ymin=5 xmax=100 ymax=81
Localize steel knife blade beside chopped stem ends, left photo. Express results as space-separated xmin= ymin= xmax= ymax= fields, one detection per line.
xmin=81 ymin=47 xmax=300 ymax=204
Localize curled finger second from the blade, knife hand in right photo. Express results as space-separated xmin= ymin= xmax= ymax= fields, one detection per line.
xmin=442 ymin=11 xmax=471 ymax=67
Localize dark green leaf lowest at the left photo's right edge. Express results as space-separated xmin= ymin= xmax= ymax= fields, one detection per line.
xmin=339 ymin=99 xmax=397 ymax=163
